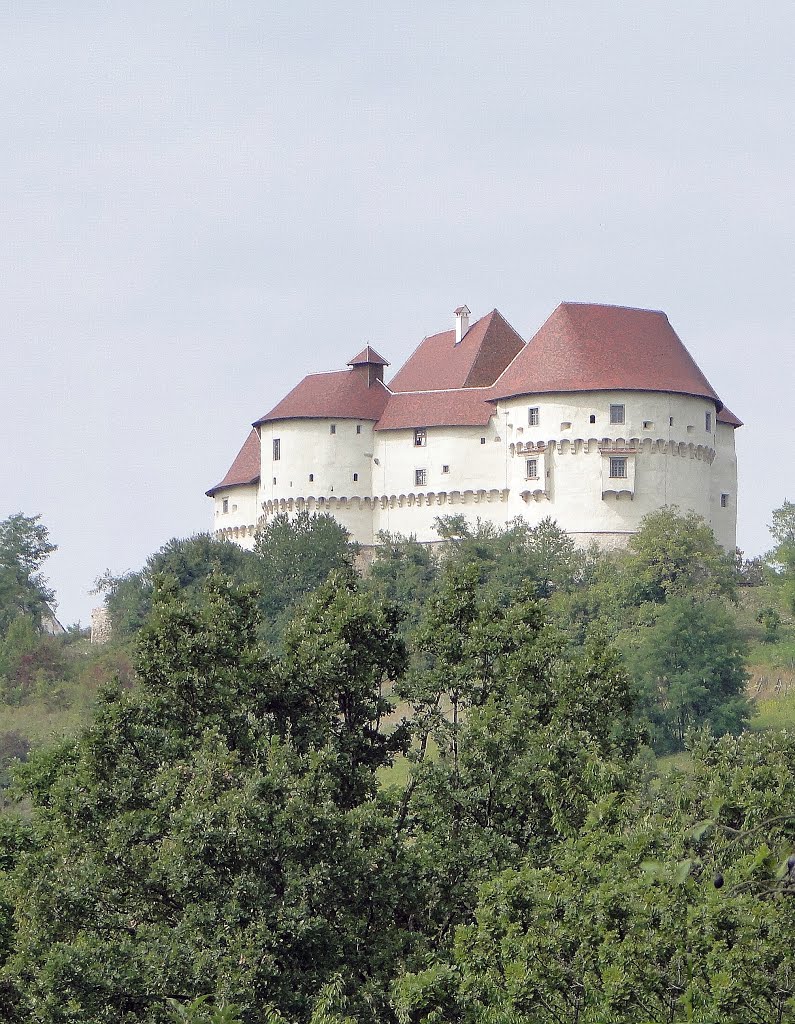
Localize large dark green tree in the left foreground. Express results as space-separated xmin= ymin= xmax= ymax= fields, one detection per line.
xmin=5 ymin=577 xmax=413 ymax=1024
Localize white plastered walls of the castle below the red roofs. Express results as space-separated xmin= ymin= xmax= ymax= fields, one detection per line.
xmin=215 ymin=391 xmax=737 ymax=549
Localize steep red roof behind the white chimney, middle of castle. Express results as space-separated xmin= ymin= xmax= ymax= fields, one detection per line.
xmin=389 ymin=307 xmax=525 ymax=391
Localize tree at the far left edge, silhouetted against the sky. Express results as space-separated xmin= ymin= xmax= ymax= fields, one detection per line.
xmin=0 ymin=512 xmax=56 ymax=637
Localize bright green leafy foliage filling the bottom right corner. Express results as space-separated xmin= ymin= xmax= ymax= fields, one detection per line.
xmin=422 ymin=733 xmax=795 ymax=1024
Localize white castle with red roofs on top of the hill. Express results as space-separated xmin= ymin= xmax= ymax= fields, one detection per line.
xmin=207 ymin=302 xmax=742 ymax=550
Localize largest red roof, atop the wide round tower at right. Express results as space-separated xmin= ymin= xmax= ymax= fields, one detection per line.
xmin=494 ymin=302 xmax=722 ymax=409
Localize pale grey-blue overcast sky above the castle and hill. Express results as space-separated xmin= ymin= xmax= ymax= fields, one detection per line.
xmin=0 ymin=0 xmax=795 ymax=623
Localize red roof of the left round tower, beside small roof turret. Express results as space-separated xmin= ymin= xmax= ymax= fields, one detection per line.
xmin=254 ymin=370 xmax=389 ymax=427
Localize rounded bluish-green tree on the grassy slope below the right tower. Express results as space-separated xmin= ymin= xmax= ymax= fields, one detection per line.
xmin=628 ymin=597 xmax=751 ymax=752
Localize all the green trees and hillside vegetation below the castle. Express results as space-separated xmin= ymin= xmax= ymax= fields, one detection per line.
xmin=0 ymin=503 xmax=795 ymax=1024
